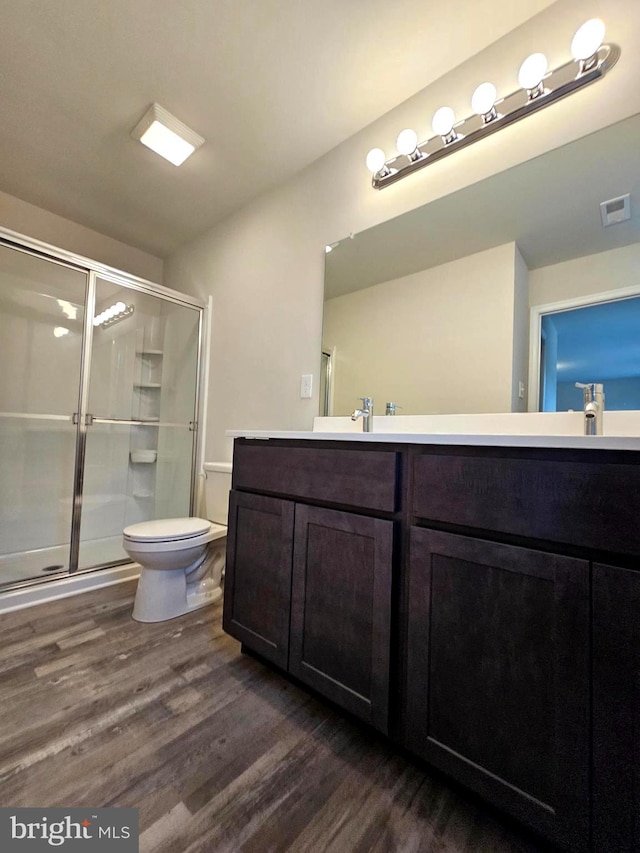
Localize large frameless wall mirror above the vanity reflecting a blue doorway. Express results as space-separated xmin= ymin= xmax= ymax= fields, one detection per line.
xmin=321 ymin=111 xmax=640 ymax=416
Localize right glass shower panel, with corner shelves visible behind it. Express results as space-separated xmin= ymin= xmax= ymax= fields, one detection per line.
xmin=79 ymin=277 xmax=200 ymax=569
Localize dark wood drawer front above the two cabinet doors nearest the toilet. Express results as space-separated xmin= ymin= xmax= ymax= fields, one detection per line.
xmin=233 ymin=441 xmax=398 ymax=512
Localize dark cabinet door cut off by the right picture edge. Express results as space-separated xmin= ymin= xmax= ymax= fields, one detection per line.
xmin=593 ymin=565 xmax=640 ymax=853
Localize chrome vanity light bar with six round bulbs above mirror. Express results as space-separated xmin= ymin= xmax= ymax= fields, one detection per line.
xmin=366 ymin=18 xmax=620 ymax=190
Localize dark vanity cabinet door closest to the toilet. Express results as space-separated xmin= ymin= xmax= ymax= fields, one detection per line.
xmin=222 ymin=491 xmax=294 ymax=669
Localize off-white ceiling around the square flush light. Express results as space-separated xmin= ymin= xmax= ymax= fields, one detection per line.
xmin=0 ymin=0 xmax=552 ymax=256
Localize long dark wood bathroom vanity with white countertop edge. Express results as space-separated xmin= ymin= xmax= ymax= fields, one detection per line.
xmin=224 ymin=433 xmax=640 ymax=853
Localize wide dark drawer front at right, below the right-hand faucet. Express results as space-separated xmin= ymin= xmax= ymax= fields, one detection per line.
xmin=412 ymin=453 xmax=640 ymax=554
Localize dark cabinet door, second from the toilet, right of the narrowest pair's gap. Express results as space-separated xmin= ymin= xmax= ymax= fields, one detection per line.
xmin=289 ymin=505 xmax=393 ymax=732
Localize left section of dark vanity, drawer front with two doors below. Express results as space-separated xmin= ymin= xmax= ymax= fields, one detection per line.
xmin=223 ymin=442 xmax=397 ymax=733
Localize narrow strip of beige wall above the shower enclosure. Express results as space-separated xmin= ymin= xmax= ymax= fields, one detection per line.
xmin=0 ymin=192 xmax=163 ymax=284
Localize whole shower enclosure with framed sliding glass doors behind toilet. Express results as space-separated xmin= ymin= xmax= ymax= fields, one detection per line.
xmin=0 ymin=229 xmax=204 ymax=589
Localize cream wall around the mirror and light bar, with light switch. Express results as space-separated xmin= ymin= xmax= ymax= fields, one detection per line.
xmin=165 ymin=0 xmax=640 ymax=459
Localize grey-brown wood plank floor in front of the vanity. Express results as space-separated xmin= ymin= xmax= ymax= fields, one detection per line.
xmin=0 ymin=583 xmax=547 ymax=853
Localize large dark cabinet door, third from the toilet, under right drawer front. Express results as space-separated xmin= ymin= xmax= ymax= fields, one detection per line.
xmin=405 ymin=528 xmax=589 ymax=850
